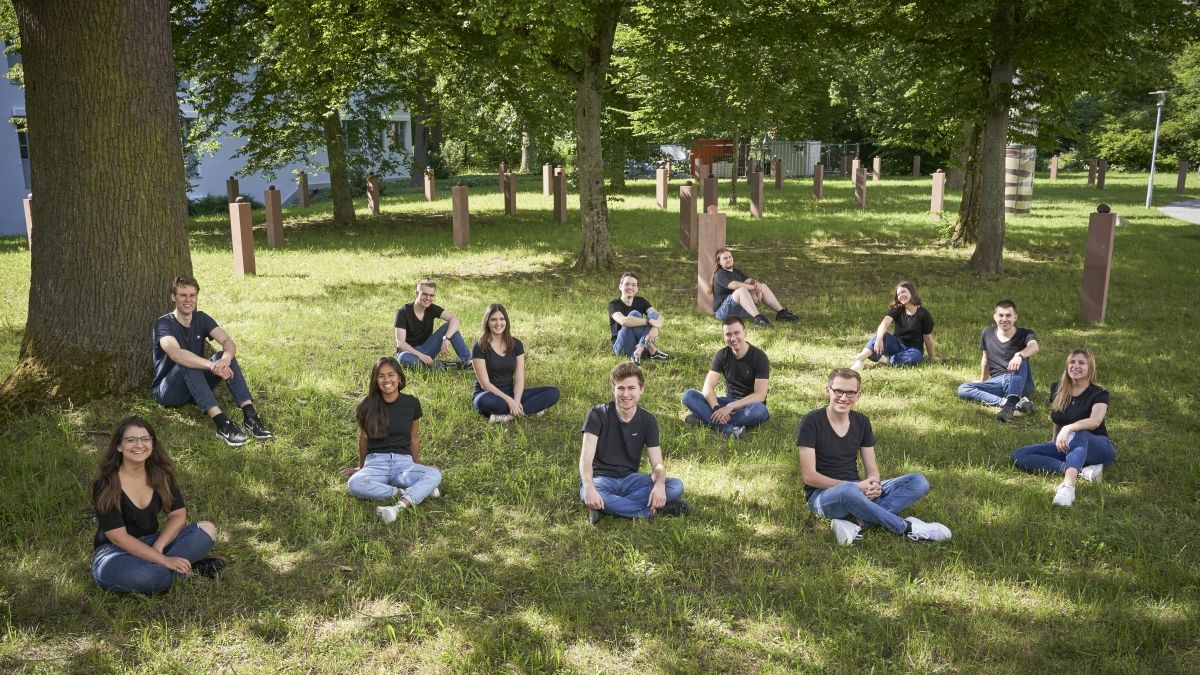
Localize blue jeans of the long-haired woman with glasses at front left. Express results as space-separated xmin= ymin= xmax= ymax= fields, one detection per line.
xmin=91 ymin=522 xmax=212 ymax=593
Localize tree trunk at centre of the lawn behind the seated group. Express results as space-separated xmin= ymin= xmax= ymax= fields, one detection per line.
xmin=572 ymin=0 xmax=622 ymax=270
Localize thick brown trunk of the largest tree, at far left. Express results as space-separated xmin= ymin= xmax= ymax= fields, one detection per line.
xmin=0 ymin=0 xmax=192 ymax=410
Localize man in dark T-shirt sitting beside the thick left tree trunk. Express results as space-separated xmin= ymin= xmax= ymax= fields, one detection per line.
xmin=150 ymin=275 xmax=272 ymax=448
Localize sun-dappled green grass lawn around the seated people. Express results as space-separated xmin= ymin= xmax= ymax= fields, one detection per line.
xmin=0 ymin=174 xmax=1200 ymax=673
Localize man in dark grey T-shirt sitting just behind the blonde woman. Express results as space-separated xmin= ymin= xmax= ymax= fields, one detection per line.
xmin=959 ymin=300 xmax=1038 ymax=422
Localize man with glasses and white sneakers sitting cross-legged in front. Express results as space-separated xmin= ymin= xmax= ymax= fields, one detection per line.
xmin=796 ymin=368 xmax=950 ymax=546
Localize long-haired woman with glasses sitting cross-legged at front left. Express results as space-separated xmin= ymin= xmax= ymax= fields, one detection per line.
xmin=89 ymin=417 xmax=229 ymax=593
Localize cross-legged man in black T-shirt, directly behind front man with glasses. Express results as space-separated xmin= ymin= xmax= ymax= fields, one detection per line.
xmin=683 ymin=316 xmax=770 ymax=438
